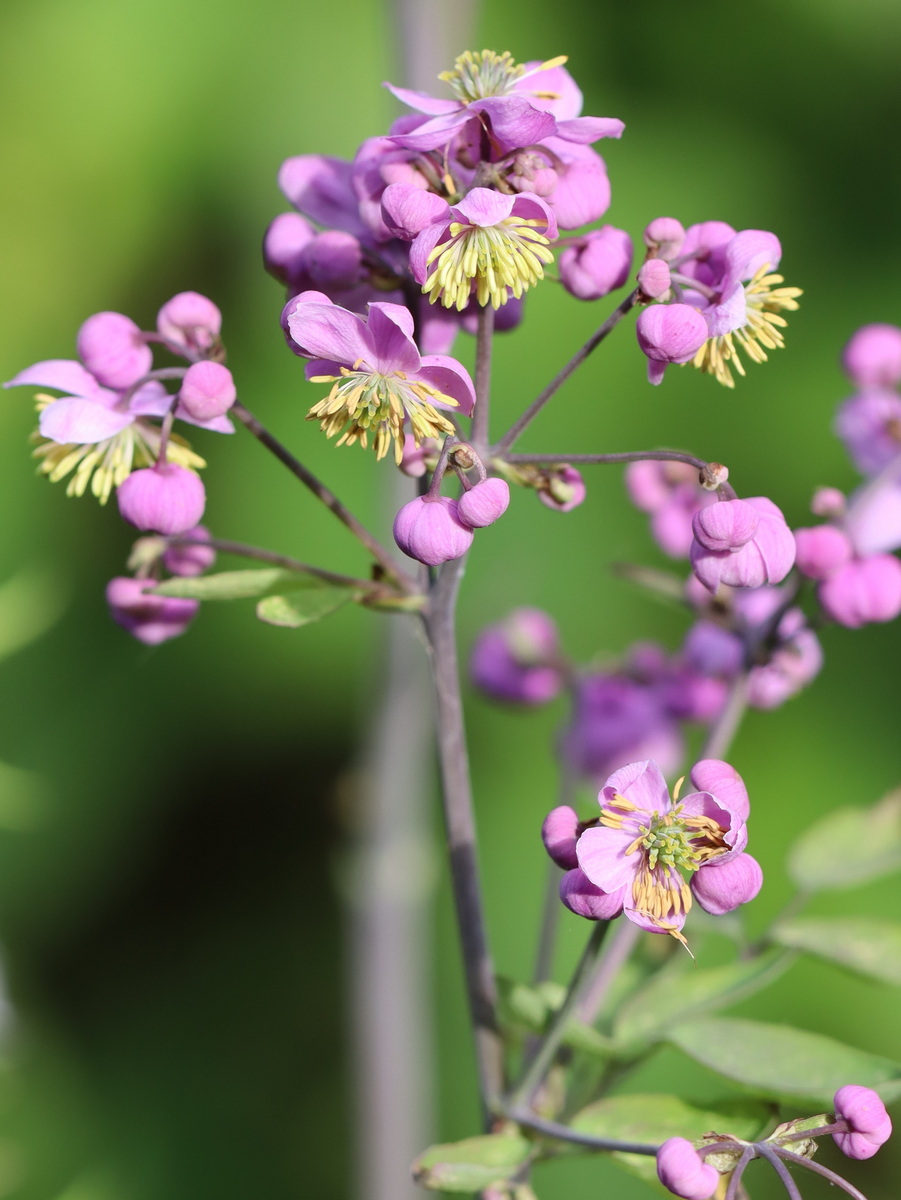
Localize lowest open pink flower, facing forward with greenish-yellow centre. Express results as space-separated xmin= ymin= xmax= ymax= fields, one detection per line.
xmin=576 ymin=761 xmax=747 ymax=934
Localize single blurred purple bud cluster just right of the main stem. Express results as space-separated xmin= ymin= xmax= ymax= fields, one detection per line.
xmin=469 ymin=608 xmax=563 ymax=700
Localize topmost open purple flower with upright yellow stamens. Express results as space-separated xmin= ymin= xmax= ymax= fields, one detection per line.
xmin=385 ymin=50 xmax=623 ymax=161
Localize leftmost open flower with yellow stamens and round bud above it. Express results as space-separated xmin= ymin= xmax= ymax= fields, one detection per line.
xmin=4 ymin=309 xmax=234 ymax=504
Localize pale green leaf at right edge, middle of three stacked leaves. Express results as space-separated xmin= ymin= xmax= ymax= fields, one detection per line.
xmin=770 ymin=917 xmax=901 ymax=985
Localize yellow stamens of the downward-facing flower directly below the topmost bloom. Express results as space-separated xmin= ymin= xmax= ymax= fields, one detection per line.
xmin=422 ymin=216 xmax=554 ymax=312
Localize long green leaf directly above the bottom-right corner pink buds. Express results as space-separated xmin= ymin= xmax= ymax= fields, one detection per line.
xmin=667 ymin=1016 xmax=901 ymax=1108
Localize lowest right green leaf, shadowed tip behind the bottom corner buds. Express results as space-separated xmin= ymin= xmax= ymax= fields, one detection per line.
xmin=570 ymin=1094 xmax=769 ymax=1195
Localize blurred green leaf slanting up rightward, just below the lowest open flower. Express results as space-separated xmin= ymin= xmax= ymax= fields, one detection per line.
xmin=613 ymin=950 xmax=792 ymax=1055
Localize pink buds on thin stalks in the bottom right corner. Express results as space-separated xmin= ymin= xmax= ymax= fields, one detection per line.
xmin=657 ymin=1084 xmax=891 ymax=1200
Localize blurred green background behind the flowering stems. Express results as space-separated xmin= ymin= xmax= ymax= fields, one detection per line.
xmin=0 ymin=0 xmax=901 ymax=1200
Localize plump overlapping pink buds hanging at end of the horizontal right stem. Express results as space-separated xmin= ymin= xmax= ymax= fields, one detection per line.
xmin=689 ymin=496 xmax=795 ymax=592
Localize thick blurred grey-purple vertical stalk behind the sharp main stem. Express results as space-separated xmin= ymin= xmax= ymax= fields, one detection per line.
xmin=349 ymin=9 xmax=475 ymax=1200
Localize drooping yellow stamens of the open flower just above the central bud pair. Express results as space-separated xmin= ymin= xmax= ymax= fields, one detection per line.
xmin=307 ymin=362 xmax=457 ymax=463
